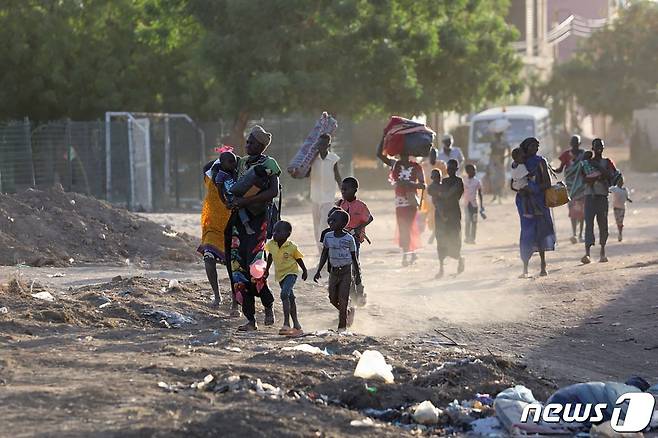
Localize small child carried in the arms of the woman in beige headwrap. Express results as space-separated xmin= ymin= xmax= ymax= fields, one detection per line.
xmin=215 ymin=151 xmax=269 ymax=234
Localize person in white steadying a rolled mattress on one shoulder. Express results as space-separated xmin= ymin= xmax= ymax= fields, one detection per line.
xmin=311 ymin=134 xmax=343 ymax=253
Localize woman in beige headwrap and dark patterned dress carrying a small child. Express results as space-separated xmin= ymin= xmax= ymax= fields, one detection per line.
xmin=226 ymin=126 xmax=281 ymax=331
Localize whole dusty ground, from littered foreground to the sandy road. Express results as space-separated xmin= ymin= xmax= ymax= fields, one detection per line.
xmin=0 ymin=146 xmax=658 ymax=436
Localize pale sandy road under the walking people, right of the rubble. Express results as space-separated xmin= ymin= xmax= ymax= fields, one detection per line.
xmin=142 ymin=151 xmax=658 ymax=381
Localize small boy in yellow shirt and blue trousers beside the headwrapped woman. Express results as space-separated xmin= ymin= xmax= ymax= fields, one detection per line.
xmin=265 ymin=221 xmax=308 ymax=336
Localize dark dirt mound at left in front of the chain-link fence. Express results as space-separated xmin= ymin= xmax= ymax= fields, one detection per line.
xmin=0 ymin=187 xmax=198 ymax=266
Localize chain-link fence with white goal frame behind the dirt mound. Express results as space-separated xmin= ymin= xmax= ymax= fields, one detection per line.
xmin=0 ymin=113 xmax=353 ymax=211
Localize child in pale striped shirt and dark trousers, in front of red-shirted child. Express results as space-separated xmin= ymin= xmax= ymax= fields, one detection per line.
xmin=313 ymin=210 xmax=361 ymax=331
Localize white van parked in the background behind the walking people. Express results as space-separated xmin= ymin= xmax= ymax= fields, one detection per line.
xmin=468 ymin=105 xmax=555 ymax=169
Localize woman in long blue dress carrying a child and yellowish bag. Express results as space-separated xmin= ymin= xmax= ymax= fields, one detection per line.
xmin=516 ymin=137 xmax=555 ymax=277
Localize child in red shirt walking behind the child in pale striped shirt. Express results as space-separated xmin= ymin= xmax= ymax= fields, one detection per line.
xmin=336 ymin=176 xmax=374 ymax=306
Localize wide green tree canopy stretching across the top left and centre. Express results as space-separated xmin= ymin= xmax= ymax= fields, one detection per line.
xmin=0 ymin=0 xmax=520 ymax=131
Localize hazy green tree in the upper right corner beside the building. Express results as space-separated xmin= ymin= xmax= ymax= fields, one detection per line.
xmin=552 ymin=1 xmax=658 ymax=124
